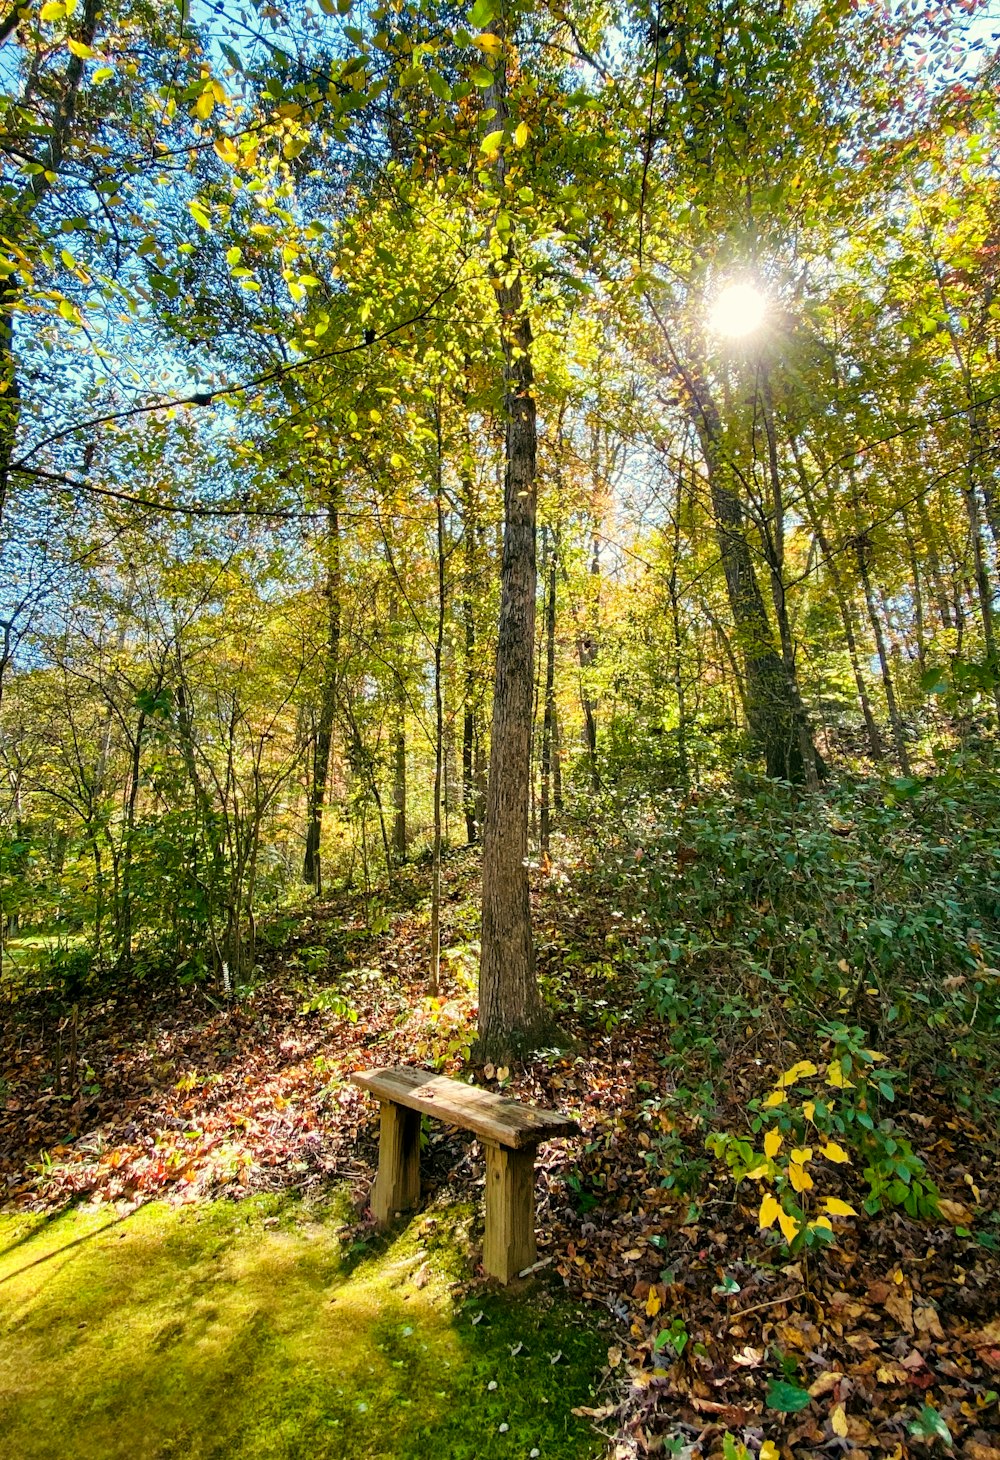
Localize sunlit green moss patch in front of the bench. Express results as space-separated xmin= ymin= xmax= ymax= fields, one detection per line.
xmin=0 ymin=1197 xmax=606 ymax=1460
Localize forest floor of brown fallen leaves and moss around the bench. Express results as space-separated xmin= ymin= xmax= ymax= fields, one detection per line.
xmin=0 ymin=856 xmax=1000 ymax=1460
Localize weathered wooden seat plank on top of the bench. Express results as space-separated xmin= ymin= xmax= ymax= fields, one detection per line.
xmin=350 ymin=1066 xmax=580 ymax=1150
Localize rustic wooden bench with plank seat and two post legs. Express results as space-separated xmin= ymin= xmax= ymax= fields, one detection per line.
xmin=350 ymin=1066 xmax=580 ymax=1283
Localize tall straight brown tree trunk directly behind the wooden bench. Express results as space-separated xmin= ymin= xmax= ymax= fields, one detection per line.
xmin=479 ymin=20 xmax=549 ymax=1059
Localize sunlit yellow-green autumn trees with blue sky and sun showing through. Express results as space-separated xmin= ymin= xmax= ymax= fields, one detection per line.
xmin=0 ymin=0 xmax=1000 ymax=1056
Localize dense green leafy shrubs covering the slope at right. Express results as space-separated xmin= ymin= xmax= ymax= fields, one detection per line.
xmin=618 ymin=762 xmax=1000 ymax=1040
